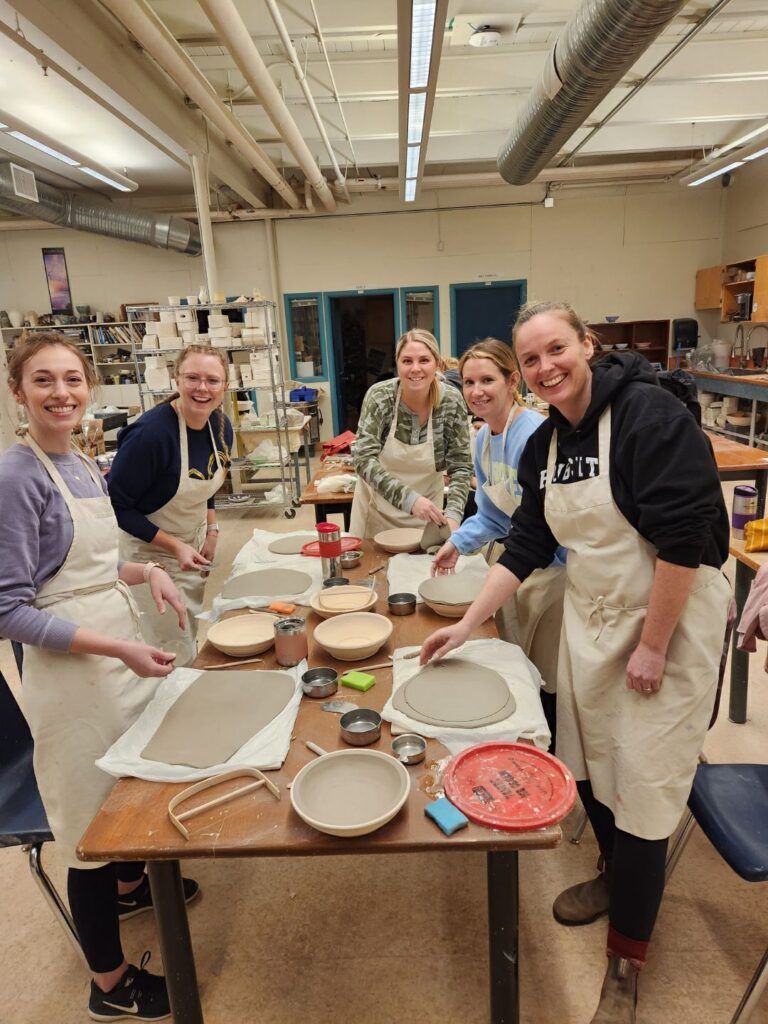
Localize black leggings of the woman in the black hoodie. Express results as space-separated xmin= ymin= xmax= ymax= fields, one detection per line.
xmin=577 ymin=781 xmax=669 ymax=942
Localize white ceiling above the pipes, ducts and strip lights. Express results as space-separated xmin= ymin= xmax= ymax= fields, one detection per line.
xmin=0 ymin=0 xmax=768 ymax=207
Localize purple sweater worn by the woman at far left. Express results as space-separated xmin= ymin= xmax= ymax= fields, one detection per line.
xmin=0 ymin=444 xmax=105 ymax=651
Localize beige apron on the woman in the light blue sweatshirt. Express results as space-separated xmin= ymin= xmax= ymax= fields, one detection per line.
xmin=480 ymin=404 xmax=565 ymax=693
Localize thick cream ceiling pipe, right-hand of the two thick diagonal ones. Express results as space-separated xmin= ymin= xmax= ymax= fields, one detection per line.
xmin=200 ymin=0 xmax=336 ymax=213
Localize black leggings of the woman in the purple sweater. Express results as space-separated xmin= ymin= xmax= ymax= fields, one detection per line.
xmin=67 ymin=861 xmax=144 ymax=974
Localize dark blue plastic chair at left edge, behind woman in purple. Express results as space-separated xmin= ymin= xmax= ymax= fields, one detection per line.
xmin=0 ymin=653 xmax=85 ymax=963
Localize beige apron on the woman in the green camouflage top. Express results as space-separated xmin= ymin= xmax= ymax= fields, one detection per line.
xmin=349 ymin=385 xmax=444 ymax=540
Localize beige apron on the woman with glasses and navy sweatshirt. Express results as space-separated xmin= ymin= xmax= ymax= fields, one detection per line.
xmin=120 ymin=410 xmax=226 ymax=668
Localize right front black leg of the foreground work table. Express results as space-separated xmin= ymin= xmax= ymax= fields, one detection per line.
xmin=486 ymin=850 xmax=520 ymax=1024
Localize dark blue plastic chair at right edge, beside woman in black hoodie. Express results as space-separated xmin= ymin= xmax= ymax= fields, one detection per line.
xmin=667 ymin=763 xmax=768 ymax=1024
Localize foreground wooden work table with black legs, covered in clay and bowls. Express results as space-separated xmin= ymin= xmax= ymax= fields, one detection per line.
xmin=78 ymin=542 xmax=562 ymax=1024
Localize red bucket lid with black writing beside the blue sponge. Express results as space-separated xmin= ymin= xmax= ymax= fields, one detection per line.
xmin=443 ymin=743 xmax=577 ymax=831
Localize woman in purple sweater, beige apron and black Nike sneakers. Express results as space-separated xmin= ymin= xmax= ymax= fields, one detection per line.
xmin=0 ymin=333 xmax=191 ymax=1021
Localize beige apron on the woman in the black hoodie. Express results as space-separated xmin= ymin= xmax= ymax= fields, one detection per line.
xmin=545 ymin=408 xmax=730 ymax=840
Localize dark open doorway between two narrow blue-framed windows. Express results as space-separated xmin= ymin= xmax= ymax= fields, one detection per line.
xmin=328 ymin=291 xmax=396 ymax=433
